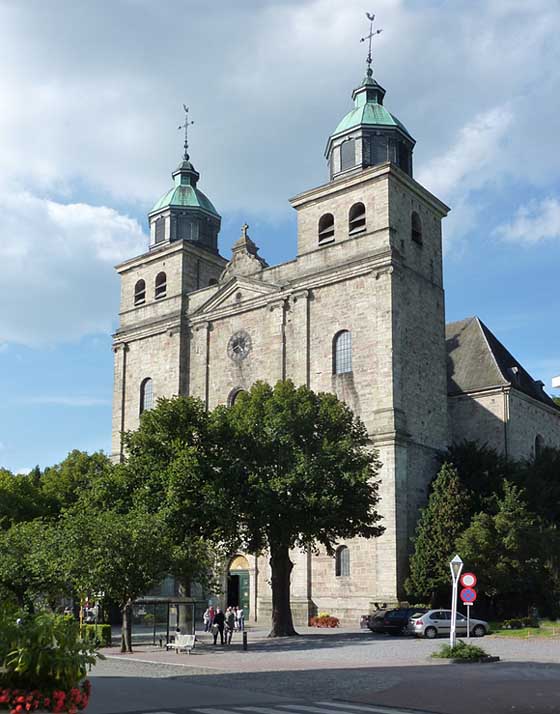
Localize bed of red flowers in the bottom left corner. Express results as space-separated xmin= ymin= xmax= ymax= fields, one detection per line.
xmin=0 ymin=679 xmax=91 ymax=714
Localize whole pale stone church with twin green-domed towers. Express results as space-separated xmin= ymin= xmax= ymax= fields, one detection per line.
xmin=112 ymin=61 xmax=560 ymax=623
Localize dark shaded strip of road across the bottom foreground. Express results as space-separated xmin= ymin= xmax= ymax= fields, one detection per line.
xmin=89 ymin=662 xmax=560 ymax=714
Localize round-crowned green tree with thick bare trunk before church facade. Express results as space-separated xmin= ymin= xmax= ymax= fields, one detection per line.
xmin=221 ymin=381 xmax=383 ymax=636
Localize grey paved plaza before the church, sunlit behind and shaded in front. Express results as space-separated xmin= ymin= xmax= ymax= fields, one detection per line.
xmin=89 ymin=628 xmax=560 ymax=714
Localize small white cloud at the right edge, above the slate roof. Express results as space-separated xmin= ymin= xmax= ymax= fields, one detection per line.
xmin=495 ymin=198 xmax=560 ymax=245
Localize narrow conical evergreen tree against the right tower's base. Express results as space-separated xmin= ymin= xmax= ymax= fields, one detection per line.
xmin=406 ymin=463 xmax=471 ymax=606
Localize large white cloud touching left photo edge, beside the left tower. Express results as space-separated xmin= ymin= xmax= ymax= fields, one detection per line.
xmin=0 ymin=192 xmax=147 ymax=346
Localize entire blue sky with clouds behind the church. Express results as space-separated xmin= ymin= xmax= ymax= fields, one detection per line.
xmin=0 ymin=0 xmax=560 ymax=472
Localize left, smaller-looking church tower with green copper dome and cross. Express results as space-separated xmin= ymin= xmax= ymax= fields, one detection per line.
xmin=112 ymin=107 xmax=226 ymax=461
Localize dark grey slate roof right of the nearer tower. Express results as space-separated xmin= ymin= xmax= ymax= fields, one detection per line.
xmin=445 ymin=317 xmax=558 ymax=409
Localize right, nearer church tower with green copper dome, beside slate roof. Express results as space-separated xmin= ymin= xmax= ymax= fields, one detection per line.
xmin=291 ymin=32 xmax=449 ymax=612
